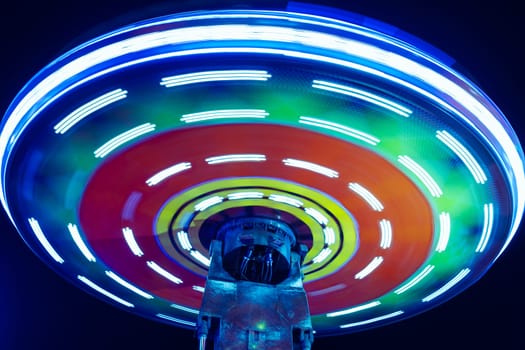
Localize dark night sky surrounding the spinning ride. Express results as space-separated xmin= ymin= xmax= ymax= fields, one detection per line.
xmin=0 ymin=0 xmax=525 ymax=350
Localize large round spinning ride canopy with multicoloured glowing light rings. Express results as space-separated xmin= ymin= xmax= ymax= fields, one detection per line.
xmin=0 ymin=4 xmax=525 ymax=335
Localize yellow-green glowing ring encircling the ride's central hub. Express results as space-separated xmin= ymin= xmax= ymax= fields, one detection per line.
xmin=151 ymin=177 xmax=358 ymax=282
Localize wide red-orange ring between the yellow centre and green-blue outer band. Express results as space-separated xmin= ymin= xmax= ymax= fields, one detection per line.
xmin=79 ymin=124 xmax=434 ymax=315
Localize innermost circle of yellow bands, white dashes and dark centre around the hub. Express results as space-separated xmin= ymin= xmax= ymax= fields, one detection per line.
xmin=149 ymin=177 xmax=357 ymax=280
